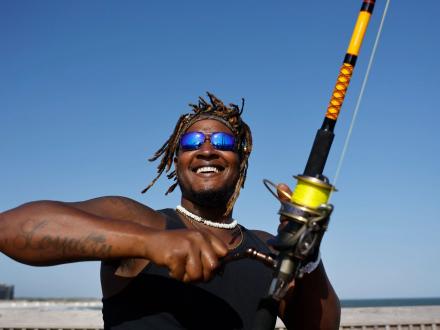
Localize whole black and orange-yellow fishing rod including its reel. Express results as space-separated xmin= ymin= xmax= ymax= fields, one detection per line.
xmin=254 ymin=0 xmax=375 ymax=330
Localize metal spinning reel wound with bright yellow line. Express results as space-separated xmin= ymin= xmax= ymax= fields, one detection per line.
xmin=263 ymin=175 xmax=335 ymax=300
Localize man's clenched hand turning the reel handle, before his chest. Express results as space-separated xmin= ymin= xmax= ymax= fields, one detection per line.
xmin=148 ymin=229 xmax=228 ymax=282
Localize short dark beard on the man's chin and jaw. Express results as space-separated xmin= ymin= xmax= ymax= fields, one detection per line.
xmin=177 ymin=180 xmax=236 ymax=208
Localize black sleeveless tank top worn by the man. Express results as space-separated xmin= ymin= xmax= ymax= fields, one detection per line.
xmin=102 ymin=209 xmax=272 ymax=330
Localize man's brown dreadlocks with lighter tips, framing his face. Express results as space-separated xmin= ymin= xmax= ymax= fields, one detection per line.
xmin=142 ymin=92 xmax=252 ymax=215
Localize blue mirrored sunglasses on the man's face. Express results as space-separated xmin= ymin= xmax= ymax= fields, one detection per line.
xmin=180 ymin=132 xmax=235 ymax=151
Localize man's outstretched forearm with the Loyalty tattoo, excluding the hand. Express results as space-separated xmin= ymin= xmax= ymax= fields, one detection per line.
xmin=0 ymin=202 xmax=154 ymax=265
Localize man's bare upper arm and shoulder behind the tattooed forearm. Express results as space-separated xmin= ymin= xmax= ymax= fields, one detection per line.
xmin=66 ymin=196 xmax=165 ymax=229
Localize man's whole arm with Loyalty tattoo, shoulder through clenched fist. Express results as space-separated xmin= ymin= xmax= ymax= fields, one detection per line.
xmin=0 ymin=197 xmax=227 ymax=281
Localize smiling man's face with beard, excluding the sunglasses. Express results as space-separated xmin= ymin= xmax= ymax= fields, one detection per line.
xmin=175 ymin=119 xmax=240 ymax=207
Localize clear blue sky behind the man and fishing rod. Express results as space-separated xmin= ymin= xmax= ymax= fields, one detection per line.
xmin=0 ymin=0 xmax=440 ymax=298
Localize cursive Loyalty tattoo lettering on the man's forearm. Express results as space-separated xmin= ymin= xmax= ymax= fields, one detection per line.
xmin=13 ymin=220 xmax=112 ymax=258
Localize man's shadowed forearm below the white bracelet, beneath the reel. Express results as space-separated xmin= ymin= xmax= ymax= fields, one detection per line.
xmin=281 ymin=263 xmax=341 ymax=330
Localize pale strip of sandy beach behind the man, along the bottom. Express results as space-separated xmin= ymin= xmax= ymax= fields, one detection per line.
xmin=0 ymin=300 xmax=440 ymax=330
